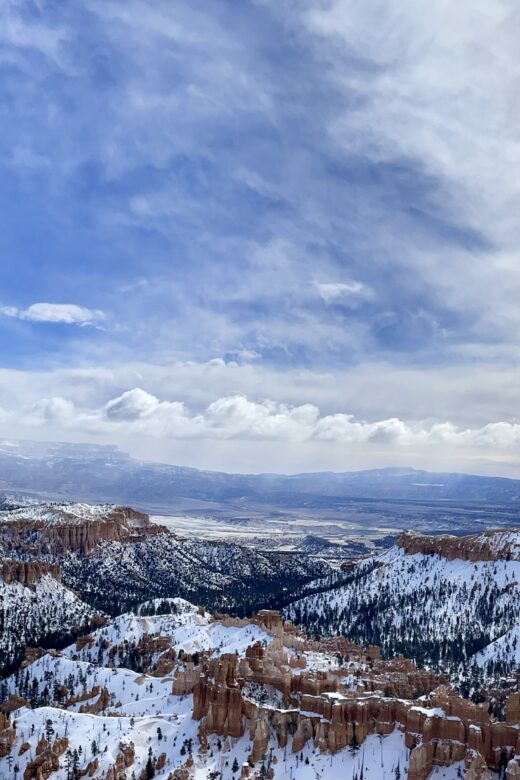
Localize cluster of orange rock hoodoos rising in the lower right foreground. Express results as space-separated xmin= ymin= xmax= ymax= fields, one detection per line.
xmin=189 ymin=613 xmax=520 ymax=780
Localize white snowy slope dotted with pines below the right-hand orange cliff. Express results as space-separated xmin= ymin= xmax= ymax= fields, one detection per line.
xmin=286 ymin=532 xmax=520 ymax=676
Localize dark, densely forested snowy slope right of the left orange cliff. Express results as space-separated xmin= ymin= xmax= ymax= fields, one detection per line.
xmin=61 ymin=531 xmax=331 ymax=614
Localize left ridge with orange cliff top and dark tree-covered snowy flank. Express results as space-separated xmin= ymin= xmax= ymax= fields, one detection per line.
xmin=0 ymin=502 xmax=332 ymax=614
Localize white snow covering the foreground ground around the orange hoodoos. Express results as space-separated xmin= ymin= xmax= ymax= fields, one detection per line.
xmin=0 ymin=599 xmax=416 ymax=780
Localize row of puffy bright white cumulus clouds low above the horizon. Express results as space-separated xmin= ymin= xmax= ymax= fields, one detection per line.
xmin=15 ymin=388 xmax=520 ymax=455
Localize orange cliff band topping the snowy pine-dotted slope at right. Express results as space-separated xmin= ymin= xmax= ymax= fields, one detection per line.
xmin=396 ymin=529 xmax=520 ymax=562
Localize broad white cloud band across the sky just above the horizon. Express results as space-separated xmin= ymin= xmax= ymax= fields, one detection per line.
xmin=0 ymin=359 xmax=520 ymax=476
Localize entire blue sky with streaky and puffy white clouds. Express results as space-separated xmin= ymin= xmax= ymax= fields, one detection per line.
xmin=0 ymin=0 xmax=520 ymax=477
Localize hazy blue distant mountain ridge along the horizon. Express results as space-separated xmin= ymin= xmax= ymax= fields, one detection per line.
xmin=0 ymin=440 xmax=520 ymax=507
